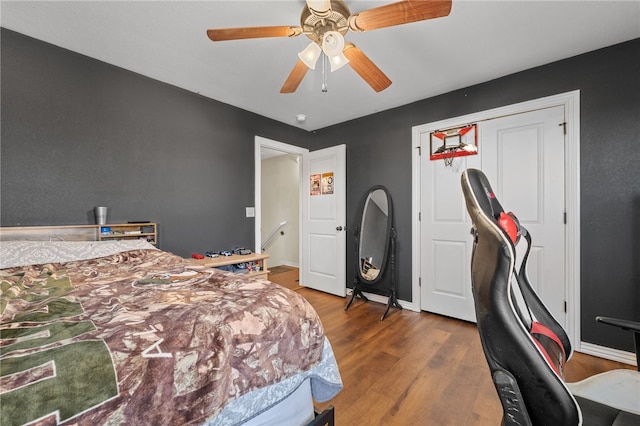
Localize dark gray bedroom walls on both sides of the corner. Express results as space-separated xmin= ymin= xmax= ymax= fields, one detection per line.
xmin=0 ymin=29 xmax=640 ymax=350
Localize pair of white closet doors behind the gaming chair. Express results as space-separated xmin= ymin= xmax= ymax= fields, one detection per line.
xmin=421 ymin=106 xmax=565 ymax=325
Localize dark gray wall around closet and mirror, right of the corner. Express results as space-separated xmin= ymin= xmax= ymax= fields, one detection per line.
xmin=311 ymin=39 xmax=640 ymax=351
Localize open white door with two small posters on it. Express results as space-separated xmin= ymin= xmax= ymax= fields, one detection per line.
xmin=300 ymin=145 xmax=347 ymax=297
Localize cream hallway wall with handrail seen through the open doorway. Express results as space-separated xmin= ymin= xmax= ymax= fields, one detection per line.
xmin=261 ymin=154 xmax=300 ymax=266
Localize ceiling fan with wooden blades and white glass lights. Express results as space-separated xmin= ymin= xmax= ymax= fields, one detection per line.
xmin=207 ymin=0 xmax=451 ymax=93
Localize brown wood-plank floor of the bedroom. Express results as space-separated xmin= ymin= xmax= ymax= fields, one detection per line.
xmin=297 ymin=287 xmax=634 ymax=426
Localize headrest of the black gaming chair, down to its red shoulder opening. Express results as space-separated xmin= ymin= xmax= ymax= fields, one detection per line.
xmin=462 ymin=169 xmax=521 ymax=245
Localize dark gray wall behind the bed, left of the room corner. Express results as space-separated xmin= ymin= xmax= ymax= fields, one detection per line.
xmin=0 ymin=28 xmax=309 ymax=256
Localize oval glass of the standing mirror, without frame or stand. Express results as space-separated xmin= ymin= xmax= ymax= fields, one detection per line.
xmin=358 ymin=188 xmax=391 ymax=281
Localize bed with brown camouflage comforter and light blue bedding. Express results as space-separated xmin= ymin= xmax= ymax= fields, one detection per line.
xmin=0 ymin=228 xmax=342 ymax=425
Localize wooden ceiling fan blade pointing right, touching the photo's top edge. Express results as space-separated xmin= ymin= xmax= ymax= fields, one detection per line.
xmin=349 ymin=0 xmax=451 ymax=31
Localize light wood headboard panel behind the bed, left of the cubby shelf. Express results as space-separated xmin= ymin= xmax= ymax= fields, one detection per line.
xmin=0 ymin=225 xmax=100 ymax=241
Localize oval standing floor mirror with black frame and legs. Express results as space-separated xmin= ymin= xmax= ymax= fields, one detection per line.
xmin=345 ymin=185 xmax=402 ymax=321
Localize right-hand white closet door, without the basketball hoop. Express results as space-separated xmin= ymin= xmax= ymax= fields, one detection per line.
xmin=481 ymin=106 xmax=566 ymax=326
